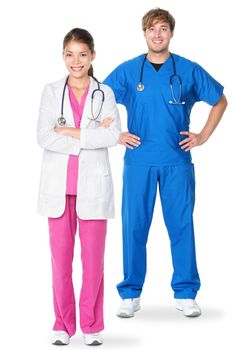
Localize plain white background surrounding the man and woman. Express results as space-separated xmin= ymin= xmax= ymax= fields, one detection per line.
xmin=0 ymin=0 xmax=233 ymax=350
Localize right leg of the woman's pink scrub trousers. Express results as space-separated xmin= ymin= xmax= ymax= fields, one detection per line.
xmin=79 ymin=219 xmax=107 ymax=333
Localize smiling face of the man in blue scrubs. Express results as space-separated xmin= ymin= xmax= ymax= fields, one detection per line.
xmin=144 ymin=19 xmax=173 ymax=53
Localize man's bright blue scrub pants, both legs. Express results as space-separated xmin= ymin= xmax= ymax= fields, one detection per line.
xmin=117 ymin=164 xmax=200 ymax=299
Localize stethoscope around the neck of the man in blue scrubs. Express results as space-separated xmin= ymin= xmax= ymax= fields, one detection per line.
xmin=137 ymin=52 xmax=185 ymax=105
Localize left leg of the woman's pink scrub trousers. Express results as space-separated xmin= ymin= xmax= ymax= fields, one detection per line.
xmin=48 ymin=195 xmax=77 ymax=336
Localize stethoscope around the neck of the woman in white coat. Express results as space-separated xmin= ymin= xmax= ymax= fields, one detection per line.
xmin=57 ymin=76 xmax=105 ymax=126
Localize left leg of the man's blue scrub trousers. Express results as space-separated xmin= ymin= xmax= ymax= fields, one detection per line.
xmin=117 ymin=165 xmax=157 ymax=299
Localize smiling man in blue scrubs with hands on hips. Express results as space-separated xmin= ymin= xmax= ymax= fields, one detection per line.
xmin=105 ymin=8 xmax=227 ymax=317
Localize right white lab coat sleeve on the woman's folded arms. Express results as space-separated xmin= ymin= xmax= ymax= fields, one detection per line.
xmin=80 ymin=87 xmax=121 ymax=149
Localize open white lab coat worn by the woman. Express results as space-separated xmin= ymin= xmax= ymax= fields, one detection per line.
xmin=37 ymin=78 xmax=121 ymax=220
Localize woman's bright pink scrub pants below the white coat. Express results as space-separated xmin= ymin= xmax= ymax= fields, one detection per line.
xmin=48 ymin=195 xmax=107 ymax=336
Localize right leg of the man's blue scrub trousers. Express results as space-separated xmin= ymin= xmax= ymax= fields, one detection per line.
xmin=159 ymin=164 xmax=200 ymax=299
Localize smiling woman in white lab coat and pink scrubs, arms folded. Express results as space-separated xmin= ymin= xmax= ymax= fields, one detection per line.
xmin=38 ymin=28 xmax=121 ymax=345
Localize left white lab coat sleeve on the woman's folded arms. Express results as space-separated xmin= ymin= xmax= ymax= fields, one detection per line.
xmin=37 ymin=85 xmax=80 ymax=156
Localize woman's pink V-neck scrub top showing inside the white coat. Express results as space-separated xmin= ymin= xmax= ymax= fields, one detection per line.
xmin=66 ymin=85 xmax=90 ymax=195
